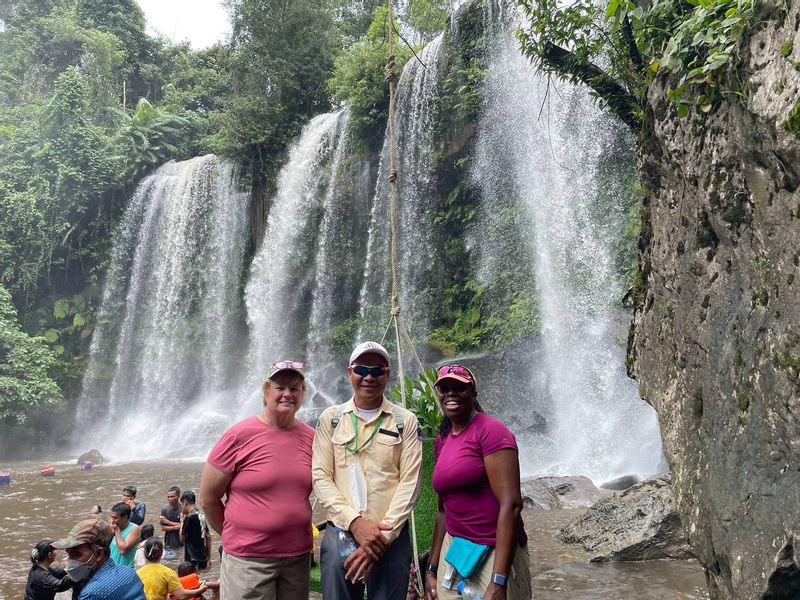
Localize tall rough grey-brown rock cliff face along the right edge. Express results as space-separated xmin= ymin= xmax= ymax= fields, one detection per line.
xmin=629 ymin=0 xmax=800 ymax=599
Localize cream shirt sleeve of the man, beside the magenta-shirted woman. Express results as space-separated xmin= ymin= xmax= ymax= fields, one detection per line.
xmin=383 ymin=412 xmax=422 ymax=542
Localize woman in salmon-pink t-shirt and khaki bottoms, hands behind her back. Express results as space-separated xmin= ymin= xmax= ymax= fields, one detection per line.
xmin=200 ymin=361 xmax=314 ymax=600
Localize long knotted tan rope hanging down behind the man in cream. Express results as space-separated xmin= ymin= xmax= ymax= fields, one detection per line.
xmin=381 ymin=0 xmax=441 ymax=595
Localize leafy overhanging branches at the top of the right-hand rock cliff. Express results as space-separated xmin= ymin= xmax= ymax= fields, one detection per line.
xmin=519 ymin=0 xmax=754 ymax=124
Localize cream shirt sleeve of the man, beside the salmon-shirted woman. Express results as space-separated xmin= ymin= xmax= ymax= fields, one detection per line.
xmin=311 ymin=413 xmax=361 ymax=529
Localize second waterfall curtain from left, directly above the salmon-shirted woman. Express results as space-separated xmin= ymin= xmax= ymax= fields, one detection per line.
xmin=241 ymin=110 xmax=368 ymax=414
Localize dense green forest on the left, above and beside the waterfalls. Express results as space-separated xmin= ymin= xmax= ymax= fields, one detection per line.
xmin=0 ymin=0 xmax=449 ymax=440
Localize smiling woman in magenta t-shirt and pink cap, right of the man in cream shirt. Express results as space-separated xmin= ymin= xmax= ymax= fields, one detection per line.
xmin=425 ymin=365 xmax=531 ymax=600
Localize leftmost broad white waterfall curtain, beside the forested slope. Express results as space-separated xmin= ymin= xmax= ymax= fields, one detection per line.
xmin=77 ymin=155 xmax=249 ymax=458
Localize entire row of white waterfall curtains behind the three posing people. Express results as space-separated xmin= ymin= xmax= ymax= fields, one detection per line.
xmin=77 ymin=10 xmax=661 ymax=481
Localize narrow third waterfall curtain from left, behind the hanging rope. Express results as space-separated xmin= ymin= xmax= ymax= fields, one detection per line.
xmin=358 ymin=34 xmax=444 ymax=346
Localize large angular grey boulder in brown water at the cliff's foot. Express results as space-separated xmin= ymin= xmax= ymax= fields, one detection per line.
xmin=559 ymin=475 xmax=693 ymax=562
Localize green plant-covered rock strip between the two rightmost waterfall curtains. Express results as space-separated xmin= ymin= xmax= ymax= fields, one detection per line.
xmin=428 ymin=2 xmax=539 ymax=356
